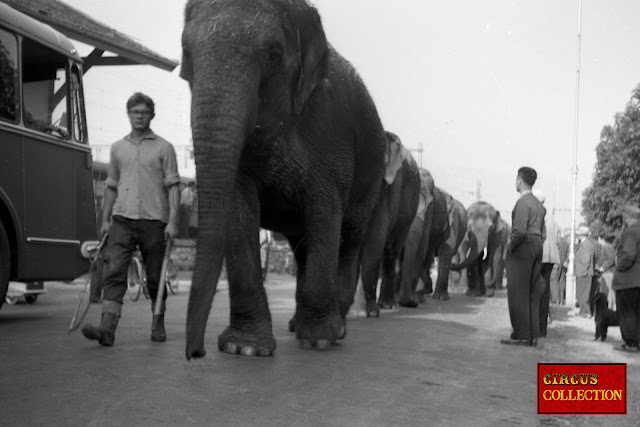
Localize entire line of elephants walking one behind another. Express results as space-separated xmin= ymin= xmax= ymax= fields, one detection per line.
xmin=181 ymin=0 xmax=507 ymax=359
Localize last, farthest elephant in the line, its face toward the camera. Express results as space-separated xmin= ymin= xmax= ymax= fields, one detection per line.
xmin=451 ymin=201 xmax=508 ymax=297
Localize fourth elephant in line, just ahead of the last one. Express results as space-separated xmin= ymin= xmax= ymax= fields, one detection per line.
xmin=418 ymin=187 xmax=467 ymax=302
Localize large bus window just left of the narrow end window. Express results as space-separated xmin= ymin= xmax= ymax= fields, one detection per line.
xmin=22 ymin=38 xmax=69 ymax=139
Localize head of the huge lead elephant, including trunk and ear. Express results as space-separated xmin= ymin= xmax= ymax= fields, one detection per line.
xmin=181 ymin=0 xmax=329 ymax=358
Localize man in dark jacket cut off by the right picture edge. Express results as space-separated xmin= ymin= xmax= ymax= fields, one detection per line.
xmin=613 ymin=205 xmax=640 ymax=353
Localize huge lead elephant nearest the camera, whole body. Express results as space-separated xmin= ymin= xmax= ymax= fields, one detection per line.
xmin=181 ymin=0 xmax=387 ymax=359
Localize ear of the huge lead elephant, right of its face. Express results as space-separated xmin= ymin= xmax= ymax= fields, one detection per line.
xmin=291 ymin=5 xmax=329 ymax=114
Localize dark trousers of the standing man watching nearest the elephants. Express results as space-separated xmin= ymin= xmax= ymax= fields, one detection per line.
xmin=507 ymin=236 xmax=542 ymax=340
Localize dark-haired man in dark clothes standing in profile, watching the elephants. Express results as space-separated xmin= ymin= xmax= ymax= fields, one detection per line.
xmin=500 ymin=167 xmax=546 ymax=346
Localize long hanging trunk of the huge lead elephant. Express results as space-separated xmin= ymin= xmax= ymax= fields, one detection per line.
xmin=186 ymin=68 xmax=257 ymax=359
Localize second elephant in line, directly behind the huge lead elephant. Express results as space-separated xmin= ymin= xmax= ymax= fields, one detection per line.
xmin=360 ymin=132 xmax=420 ymax=317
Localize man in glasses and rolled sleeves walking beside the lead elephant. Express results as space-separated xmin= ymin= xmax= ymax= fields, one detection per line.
xmin=82 ymin=92 xmax=180 ymax=346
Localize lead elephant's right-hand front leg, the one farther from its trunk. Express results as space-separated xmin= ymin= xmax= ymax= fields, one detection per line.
xmin=295 ymin=208 xmax=346 ymax=349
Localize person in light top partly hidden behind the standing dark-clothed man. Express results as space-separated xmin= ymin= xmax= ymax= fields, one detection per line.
xmin=533 ymin=190 xmax=560 ymax=337
